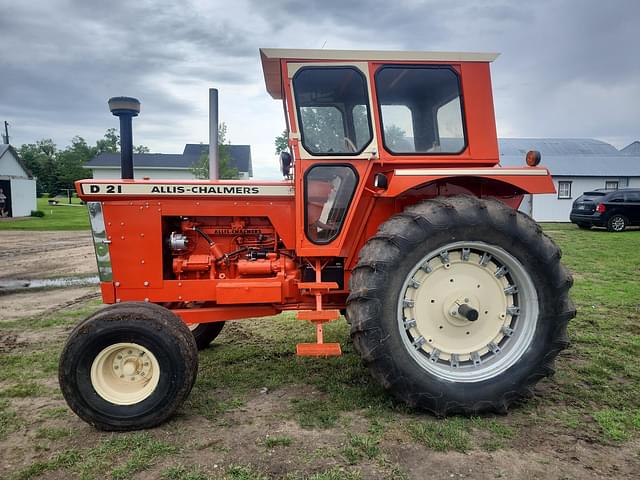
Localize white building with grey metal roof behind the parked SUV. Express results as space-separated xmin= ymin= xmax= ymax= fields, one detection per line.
xmin=499 ymin=138 xmax=640 ymax=222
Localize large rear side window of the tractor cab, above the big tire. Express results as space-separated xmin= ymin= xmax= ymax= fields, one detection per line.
xmin=376 ymin=66 xmax=466 ymax=155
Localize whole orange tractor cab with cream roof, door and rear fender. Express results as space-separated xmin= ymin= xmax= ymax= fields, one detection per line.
xmin=260 ymin=49 xmax=553 ymax=255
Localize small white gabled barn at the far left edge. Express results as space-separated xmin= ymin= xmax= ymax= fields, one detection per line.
xmin=0 ymin=144 xmax=37 ymax=217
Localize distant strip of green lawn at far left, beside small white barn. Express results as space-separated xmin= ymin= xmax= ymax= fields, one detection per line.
xmin=0 ymin=197 xmax=89 ymax=230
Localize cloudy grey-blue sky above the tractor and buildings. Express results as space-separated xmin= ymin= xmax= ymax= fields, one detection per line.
xmin=0 ymin=0 xmax=640 ymax=179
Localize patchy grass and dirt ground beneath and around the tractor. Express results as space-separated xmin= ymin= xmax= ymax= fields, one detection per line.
xmin=0 ymin=224 xmax=640 ymax=480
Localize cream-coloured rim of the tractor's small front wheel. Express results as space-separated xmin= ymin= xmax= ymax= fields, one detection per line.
xmin=91 ymin=343 xmax=160 ymax=405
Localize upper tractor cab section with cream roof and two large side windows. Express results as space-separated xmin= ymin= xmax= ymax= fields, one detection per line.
xmin=260 ymin=49 xmax=497 ymax=165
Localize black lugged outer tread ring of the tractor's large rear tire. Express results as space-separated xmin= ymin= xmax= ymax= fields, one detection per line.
xmin=347 ymin=195 xmax=576 ymax=417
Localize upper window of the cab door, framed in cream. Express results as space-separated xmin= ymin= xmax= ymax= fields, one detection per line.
xmin=293 ymin=67 xmax=373 ymax=155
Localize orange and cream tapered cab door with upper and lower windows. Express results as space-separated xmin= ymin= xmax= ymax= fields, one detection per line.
xmin=287 ymin=62 xmax=377 ymax=256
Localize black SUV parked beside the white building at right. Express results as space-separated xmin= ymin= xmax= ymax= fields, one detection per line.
xmin=569 ymin=188 xmax=640 ymax=232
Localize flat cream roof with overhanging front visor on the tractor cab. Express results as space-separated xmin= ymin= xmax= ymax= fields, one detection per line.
xmin=260 ymin=48 xmax=499 ymax=99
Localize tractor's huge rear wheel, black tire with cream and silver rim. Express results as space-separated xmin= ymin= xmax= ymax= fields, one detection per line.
xmin=347 ymin=196 xmax=575 ymax=416
